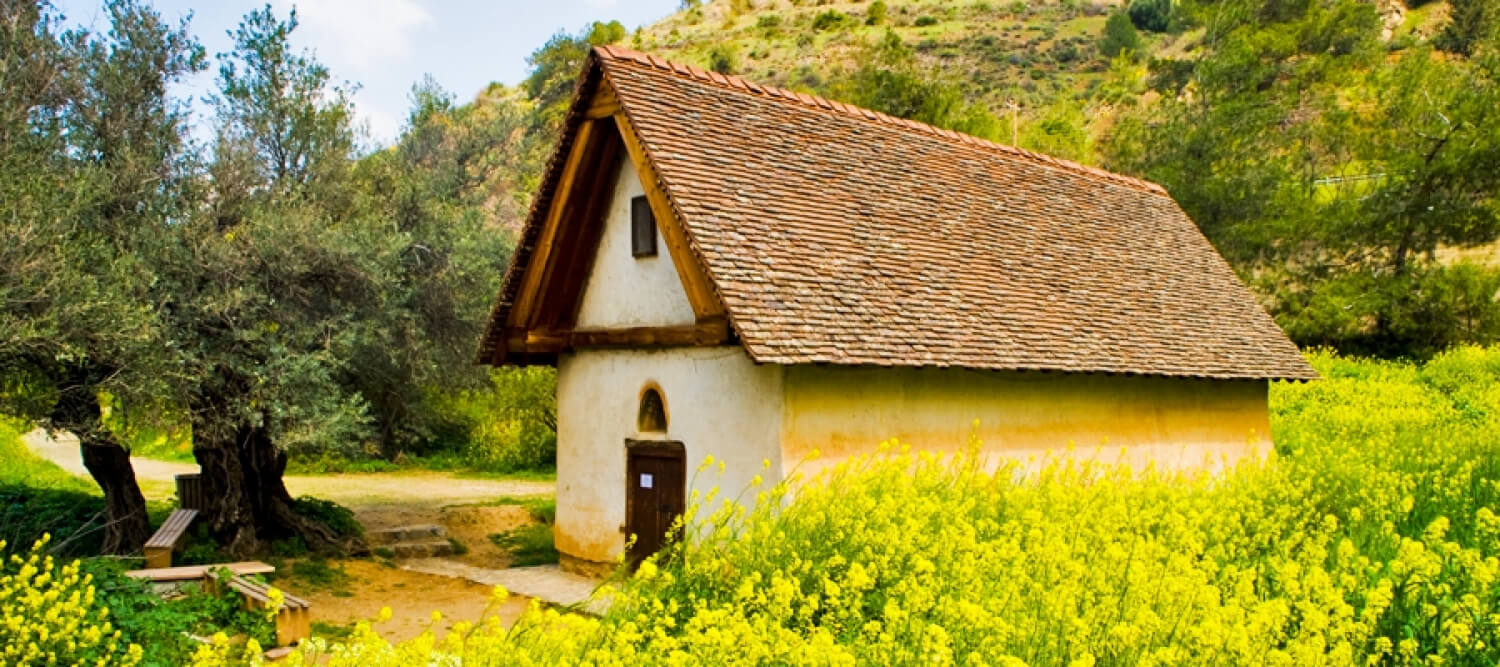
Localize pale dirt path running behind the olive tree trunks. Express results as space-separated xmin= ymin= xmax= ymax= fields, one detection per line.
xmin=26 ymin=430 xmax=555 ymax=513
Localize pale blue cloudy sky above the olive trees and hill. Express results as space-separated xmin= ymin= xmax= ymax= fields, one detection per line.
xmin=54 ymin=0 xmax=680 ymax=144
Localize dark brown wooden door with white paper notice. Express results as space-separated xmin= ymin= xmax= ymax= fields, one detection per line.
xmin=626 ymin=442 xmax=687 ymax=564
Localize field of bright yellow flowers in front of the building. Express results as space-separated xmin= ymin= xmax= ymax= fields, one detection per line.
xmin=0 ymin=349 xmax=1500 ymax=667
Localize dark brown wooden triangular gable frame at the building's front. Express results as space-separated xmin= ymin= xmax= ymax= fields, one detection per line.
xmin=480 ymin=76 xmax=729 ymax=364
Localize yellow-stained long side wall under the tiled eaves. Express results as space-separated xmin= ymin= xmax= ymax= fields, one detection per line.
xmin=782 ymin=366 xmax=1271 ymax=472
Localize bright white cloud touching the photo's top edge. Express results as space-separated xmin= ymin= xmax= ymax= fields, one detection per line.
xmin=276 ymin=0 xmax=432 ymax=72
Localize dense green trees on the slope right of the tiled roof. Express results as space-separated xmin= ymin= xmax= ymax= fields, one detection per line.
xmin=1106 ymin=0 xmax=1500 ymax=355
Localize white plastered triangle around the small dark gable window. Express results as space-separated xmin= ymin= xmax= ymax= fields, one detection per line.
xmin=578 ymin=159 xmax=696 ymax=328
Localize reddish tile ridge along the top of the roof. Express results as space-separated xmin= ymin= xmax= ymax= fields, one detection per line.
xmin=594 ymin=45 xmax=1167 ymax=195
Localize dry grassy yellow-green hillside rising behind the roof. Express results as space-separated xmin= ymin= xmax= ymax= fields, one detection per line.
xmin=623 ymin=0 xmax=1448 ymax=162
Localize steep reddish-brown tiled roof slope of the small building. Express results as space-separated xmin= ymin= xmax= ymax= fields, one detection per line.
xmin=477 ymin=46 xmax=1316 ymax=379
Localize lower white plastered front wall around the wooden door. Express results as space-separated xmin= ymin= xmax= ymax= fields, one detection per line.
xmin=555 ymin=346 xmax=783 ymax=562
